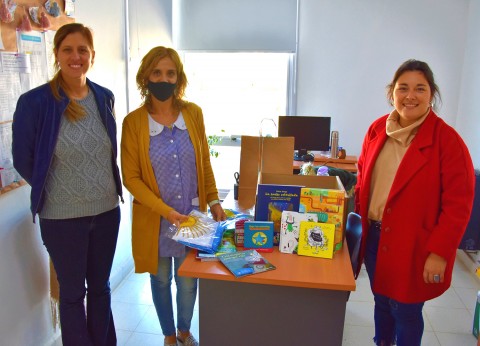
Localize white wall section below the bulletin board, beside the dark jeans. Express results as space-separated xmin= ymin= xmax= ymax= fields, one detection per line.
xmin=0 ymin=186 xmax=54 ymax=346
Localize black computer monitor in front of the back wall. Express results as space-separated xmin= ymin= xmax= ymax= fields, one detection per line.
xmin=278 ymin=115 xmax=331 ymax=160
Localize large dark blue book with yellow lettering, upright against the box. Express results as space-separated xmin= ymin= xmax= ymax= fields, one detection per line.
xmin=255 ymin=184 xmax=302 ymax=245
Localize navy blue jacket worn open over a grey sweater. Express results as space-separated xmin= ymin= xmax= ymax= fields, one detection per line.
xmin=12 ymin=79 xmax=123 ymax=221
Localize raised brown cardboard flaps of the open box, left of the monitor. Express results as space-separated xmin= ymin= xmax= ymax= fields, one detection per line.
xmin=238 ymin=136 xmax=294 ymax=209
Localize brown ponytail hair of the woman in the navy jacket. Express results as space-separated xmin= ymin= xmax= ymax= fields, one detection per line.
xmin=49 ymin=23 xmax=94 ymax=121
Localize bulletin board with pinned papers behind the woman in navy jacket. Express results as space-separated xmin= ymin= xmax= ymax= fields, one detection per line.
xmin=0 ymin=0 xmax=75 ymax=194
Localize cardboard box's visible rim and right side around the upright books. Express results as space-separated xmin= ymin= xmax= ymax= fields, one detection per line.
xmin=259 ymin=173 xmax=349 ymax=251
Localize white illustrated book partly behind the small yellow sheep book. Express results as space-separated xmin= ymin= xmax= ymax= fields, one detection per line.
xmin=279 ymin=210 xmax=318 ymax=254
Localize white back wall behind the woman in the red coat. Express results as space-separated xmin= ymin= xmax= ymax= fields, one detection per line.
xmin=297 ymin=0 xmax=472 ymax=159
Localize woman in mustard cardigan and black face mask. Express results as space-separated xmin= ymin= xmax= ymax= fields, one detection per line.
xmin=121 ymin=47 xmax=226 ymax=346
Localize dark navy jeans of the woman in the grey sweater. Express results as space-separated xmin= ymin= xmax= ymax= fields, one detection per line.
xmin=40 ymin=207 xmax=120 ymax=346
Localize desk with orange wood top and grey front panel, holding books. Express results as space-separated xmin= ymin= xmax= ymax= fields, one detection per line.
xmin=178 ymin=194 xmax=355 ymax=346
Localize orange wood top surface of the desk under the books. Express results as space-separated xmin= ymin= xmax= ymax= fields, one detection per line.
xmin=178 ymin=247 xmax=356 ymax=291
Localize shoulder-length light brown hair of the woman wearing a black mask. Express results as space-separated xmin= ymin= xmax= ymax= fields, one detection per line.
xmin=136 ymin=46 xmax=188 ymax=110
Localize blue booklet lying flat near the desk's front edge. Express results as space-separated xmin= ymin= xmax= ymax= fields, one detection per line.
xmin=218 ymin=250 xmax=276 ymax=278
